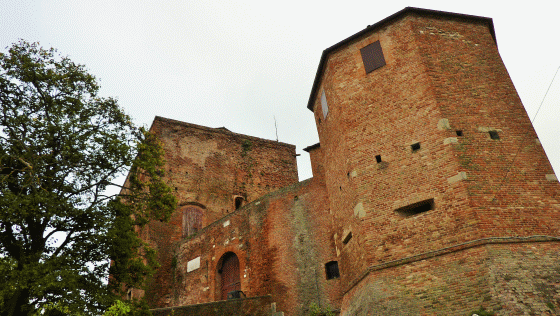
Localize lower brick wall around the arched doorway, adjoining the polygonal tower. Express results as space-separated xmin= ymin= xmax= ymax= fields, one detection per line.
xmin=146 ymin=179 xmax=341 ymax=315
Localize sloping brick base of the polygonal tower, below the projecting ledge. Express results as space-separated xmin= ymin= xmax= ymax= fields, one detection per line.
xmin=336 ymin=240 xmax=560 ymax=316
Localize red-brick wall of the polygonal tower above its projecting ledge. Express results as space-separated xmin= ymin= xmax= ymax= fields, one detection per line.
xmin=306 ymin=8 xmax=560 ymax=315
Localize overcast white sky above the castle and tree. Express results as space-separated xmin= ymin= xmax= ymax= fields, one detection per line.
xmin=0 ymin=0 xmax=560 ymax=179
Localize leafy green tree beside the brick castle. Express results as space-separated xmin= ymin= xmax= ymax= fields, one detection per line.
xmin=0 ymin=41 xmax=175 ymax=316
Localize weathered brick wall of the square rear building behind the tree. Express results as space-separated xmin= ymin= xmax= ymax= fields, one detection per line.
xmin=143 ymin=117 xmax=298 ymax=306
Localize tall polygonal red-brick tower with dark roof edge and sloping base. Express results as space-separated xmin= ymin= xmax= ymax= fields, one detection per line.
xmin=308 ymin=8 xmax=560 ymax=315
